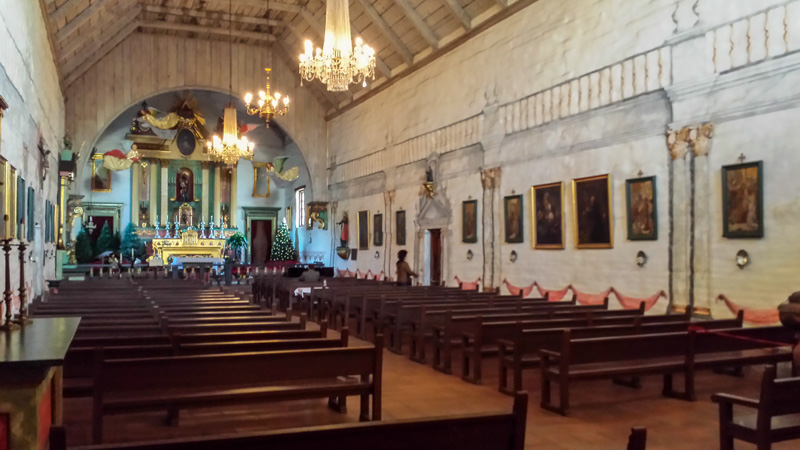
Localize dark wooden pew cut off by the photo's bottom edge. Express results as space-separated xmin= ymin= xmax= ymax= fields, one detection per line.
xmin=50 ymin=392 xmax=524 ymax=450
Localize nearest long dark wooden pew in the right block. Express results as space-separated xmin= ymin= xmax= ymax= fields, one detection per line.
xmin=539 ymin=327 xmax=794 ymax=415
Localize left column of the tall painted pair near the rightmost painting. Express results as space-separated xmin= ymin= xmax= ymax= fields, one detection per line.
xmin=667 ymin=128 xmax=691 ymax=311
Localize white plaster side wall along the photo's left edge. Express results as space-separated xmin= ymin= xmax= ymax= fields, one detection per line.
xmin=0 ymin=0 xmax=64 ymax=308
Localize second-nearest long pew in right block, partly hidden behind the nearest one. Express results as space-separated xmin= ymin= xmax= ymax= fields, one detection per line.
xmin=498 ymin=311 xmax=743 ymax=395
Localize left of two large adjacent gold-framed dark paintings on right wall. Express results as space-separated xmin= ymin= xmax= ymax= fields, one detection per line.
xmin=531 ymin=182 xmax=564 ymax=250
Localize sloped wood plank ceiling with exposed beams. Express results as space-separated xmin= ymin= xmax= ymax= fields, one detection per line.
xmin=39 ymin=0 xmax=508 ymax=114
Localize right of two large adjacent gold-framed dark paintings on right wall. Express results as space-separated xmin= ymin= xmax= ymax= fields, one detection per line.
xmin=572 ymin=175 xmax=614 ymax=248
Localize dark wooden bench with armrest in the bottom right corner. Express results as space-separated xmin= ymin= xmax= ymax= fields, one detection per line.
xmin=711 ymin=366 xmax=800 ymax=450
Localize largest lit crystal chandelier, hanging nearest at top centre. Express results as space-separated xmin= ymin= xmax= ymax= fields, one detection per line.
xmin=300 ymin=0 xmax=375 ymax=92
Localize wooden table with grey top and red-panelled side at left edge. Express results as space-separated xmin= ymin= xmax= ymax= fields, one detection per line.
xmin=0 ymin=317 xmax=81 ymax=450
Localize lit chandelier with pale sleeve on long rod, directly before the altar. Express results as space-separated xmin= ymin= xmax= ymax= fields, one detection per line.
xmin=206 ymin=0 xmax=255 ymax=166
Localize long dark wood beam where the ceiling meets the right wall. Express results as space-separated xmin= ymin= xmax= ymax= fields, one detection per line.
xmin=325 ymin=0 xmax=537 ymax=120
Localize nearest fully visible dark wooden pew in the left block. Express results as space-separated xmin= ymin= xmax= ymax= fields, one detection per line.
xmin=92 ymin=338 xmax=383 ymax=444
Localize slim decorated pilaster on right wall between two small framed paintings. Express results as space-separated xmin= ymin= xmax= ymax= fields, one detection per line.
xmin=481 ymin=167 xmax=502 ymax=290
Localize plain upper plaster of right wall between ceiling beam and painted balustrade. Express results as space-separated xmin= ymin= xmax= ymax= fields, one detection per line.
xmin=329 ymin=0 xmax=676 ymax=163
